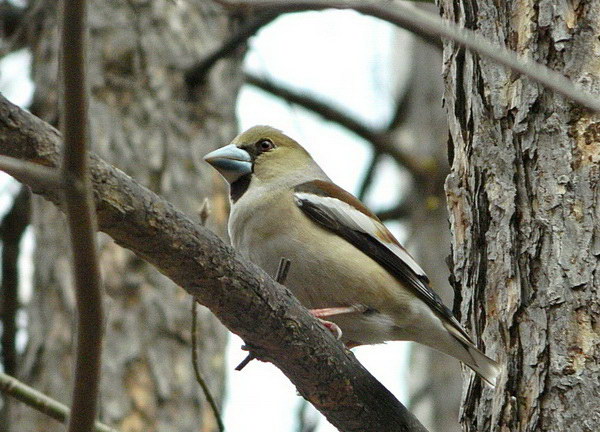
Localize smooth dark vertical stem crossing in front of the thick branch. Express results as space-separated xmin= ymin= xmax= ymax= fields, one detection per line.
xmin=61 ymin=0 xmax=103 ymax=432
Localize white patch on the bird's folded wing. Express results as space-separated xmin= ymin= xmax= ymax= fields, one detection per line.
xmin=294 ymin=192 xmax=427 ymax=278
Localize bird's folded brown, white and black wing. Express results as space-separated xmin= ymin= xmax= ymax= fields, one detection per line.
xmin=294 ymin=180 xmax=470 ymax=340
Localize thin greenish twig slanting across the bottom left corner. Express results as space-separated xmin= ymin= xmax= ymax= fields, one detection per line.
xmin=0 ymin=372 xmax=118 ymax=432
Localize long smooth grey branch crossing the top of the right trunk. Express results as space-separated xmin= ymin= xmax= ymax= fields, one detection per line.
xmin=230 ymin=0 xmax=600 ymax=112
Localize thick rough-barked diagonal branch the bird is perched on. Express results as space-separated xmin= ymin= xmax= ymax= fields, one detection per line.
xmin=0 ymin=97 xmax=425 ymax=432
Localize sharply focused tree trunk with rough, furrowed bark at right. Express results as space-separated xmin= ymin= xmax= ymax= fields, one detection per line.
xmin=439 ymin=0 xmax=600 ymax=432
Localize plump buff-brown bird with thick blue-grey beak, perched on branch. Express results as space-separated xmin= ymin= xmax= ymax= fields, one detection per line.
xmin=204 ymin=126 xmax=501 ymax=386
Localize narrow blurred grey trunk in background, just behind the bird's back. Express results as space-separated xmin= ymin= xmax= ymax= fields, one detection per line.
xmin=395 ymin=34 xmax=462 ymax=432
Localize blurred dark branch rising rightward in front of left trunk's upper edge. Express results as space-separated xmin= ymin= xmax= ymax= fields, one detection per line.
xmin=185 ymin=12 xmax=279 ymax=87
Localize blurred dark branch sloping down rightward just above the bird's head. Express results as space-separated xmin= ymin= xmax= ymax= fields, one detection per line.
xmin=246 ymin=74 xmax=421 ymax=176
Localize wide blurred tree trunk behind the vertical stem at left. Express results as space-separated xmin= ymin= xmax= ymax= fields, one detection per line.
xmin=13 ymin=0 xmax=241 ymax=432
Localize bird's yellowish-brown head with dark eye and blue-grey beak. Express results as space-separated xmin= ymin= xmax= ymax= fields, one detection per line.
xmin=204 ymin=126 xmax=320 ymax=184
